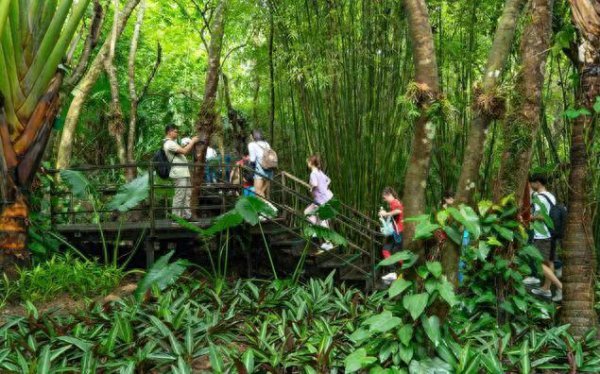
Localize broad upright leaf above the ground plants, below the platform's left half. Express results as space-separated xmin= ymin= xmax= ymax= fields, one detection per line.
xmin=134 ymin=251 xmax=190 ymax=301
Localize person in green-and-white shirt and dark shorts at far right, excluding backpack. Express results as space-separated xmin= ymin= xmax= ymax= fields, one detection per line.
xmin=529 ymin=174 xmax=562 ymax=301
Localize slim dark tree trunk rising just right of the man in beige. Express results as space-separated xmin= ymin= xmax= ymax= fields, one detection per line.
xmin=192 ymin=0 xmax=227 ymax=212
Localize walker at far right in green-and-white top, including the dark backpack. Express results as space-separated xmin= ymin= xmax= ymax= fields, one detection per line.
xmin=529 ymin=174 xmax=566 ymax=301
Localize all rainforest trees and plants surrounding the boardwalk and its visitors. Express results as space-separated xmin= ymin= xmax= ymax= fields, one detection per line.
xmin=0 ymin=0 xmax=600 ymax=373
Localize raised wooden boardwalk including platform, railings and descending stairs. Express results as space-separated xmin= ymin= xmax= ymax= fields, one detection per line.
xmin=51 ymin=165 xmax=381 ymax=288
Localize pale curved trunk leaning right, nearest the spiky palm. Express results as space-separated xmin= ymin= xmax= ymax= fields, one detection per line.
xmin=56 ymin=0 xmax=140 ymax=169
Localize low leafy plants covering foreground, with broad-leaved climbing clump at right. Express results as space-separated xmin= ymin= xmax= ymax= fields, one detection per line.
xmin=0 ymin=198 xmax=600 ymax=373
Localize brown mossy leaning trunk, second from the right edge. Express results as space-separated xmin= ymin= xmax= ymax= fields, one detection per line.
xmin=494 ymin=0 xmax=554 ymax=205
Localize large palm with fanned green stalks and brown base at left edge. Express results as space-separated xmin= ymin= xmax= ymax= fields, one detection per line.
xmin=0 ymin=0 xmax=89 ymax=271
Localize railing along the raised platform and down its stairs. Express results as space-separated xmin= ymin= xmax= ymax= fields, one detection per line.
xmin=47 ymin=162 xmax=383 ymax=284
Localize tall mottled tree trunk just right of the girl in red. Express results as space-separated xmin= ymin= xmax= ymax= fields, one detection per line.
xmin=403 ymin=0 xmax=439 ymax=251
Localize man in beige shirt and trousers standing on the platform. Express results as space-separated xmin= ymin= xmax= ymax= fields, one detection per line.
xmin=163 ymin=124 xmax=200 ymax=219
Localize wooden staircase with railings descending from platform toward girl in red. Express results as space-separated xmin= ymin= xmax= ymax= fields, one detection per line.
xmin=239 ymin=172 xmax=383 ymax=289
